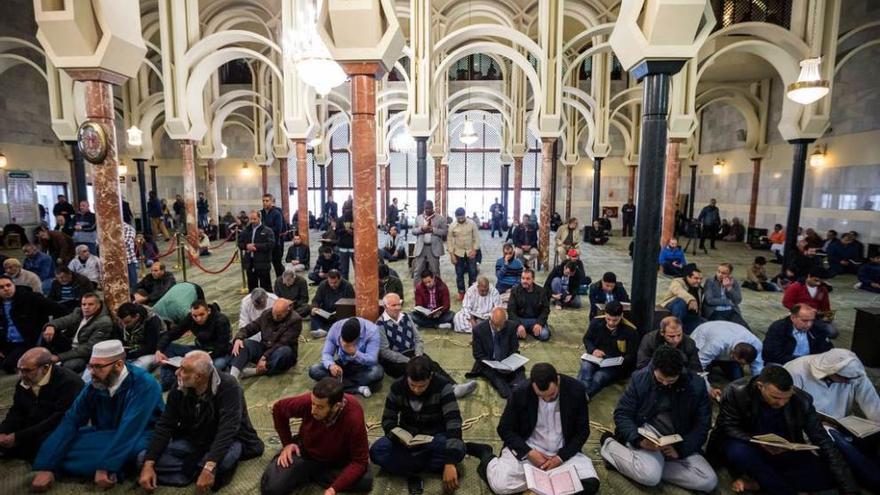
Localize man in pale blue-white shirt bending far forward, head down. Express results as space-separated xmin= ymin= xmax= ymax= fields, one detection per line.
xmin=691 ymin=321 xmax=764 ymax=400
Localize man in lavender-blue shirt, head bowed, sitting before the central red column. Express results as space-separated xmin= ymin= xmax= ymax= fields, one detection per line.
xmin=309 ymin=317 xmax=385 ymax=397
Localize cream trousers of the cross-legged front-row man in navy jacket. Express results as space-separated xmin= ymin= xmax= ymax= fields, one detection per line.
xmin=599 ymin=439 xmax=718 ymax=492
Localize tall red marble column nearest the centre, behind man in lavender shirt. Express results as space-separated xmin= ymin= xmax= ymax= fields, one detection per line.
xmin=343 ymin=62 xmax=382 ymax=321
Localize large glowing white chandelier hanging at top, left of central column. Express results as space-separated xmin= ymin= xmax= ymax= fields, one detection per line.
xmin=285 ymin=2 xmax=347 ymax=96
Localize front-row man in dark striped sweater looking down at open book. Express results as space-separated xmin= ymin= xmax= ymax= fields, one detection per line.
xmin=370 ymin=355 xmax=465 ymax=493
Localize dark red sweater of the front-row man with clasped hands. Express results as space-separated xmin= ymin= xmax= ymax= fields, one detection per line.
xmin=272 ymin=393 xmax=370 ymax=492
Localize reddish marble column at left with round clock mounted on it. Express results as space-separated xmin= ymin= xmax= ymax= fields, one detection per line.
xmin=68 ymin=70 xmax=130 ymax=320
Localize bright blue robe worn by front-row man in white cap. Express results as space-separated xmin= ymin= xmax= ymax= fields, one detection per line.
xmin=33 ymin=365 xmax=165 ymax=473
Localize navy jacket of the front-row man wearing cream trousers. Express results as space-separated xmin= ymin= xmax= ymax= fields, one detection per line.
xmin=614 ymin=366 xmax=712 ymax=459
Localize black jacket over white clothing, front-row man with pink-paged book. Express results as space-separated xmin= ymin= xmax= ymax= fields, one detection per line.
xmin=497 ymin=375 xmax=590 ymax=462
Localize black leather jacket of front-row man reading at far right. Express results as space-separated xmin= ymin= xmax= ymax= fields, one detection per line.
xmin=709 ymin=377 xmax=859 ymax=493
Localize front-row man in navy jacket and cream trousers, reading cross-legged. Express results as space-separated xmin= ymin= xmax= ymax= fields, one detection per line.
xmin=600 ymin=347 xmax=718 ymax=493
